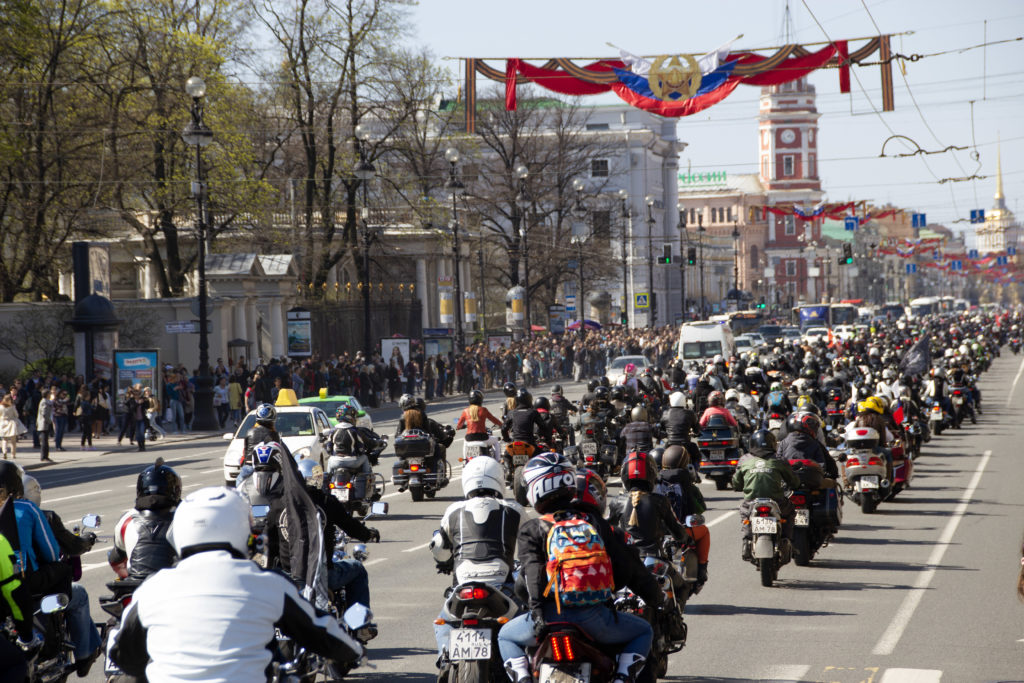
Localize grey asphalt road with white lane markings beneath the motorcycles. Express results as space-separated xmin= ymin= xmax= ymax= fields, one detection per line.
xmin=34 ymin=368 xmax=1024 ymax=683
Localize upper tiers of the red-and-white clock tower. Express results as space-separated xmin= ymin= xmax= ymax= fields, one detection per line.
xmin=758 ymin=77 xmax=821 ymax=192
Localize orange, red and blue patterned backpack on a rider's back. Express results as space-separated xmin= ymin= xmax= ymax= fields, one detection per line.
xmin=542 ymin=515 xmax=615 ymax=614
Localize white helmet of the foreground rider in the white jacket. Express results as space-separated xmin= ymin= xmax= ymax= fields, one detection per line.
xmin=168 ymin=486 xmax=252 ymax=558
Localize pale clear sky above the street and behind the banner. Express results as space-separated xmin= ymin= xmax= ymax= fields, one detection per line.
xmin=411 ymin=0 xmax=1024 ymax=230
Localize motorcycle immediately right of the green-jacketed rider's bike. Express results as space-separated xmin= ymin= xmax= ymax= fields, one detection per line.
xmin=790 ymin=460 xmax=843 ymax=566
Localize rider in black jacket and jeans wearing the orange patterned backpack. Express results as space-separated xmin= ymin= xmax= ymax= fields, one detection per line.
xmin=498 ymin=453 xmax=663 ymax=683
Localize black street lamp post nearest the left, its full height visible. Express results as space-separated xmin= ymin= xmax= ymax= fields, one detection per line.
xmin=181 ymin=76 xmax=218 ymax=431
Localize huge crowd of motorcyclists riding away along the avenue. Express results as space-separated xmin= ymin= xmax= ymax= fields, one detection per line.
xmin=0 ymin=311 xmax=1022 ymax=683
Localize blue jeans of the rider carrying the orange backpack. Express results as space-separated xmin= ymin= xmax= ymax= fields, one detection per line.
xmin=498 ymin=604 xmax=653 ymax=661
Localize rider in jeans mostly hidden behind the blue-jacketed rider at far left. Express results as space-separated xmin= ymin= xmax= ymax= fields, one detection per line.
xmin=22 ymin=474 xmax=100 ymax=678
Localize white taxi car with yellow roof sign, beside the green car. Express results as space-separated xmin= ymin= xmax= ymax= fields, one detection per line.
xmin=224 ymin=405 xmax=331 ymax=486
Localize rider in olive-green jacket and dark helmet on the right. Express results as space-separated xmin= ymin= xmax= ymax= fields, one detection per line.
xmin=732 ymin=429 xmax=800 ymax=561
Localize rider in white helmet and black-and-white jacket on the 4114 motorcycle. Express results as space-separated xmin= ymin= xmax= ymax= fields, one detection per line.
xmin=430 ymin=458 xmax=524 ymax=668
